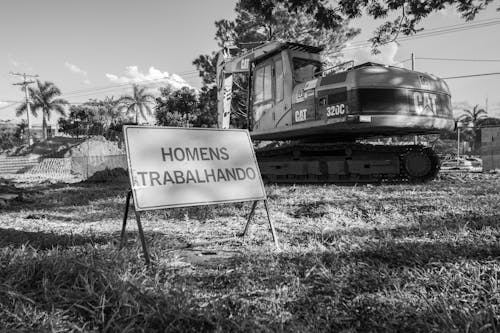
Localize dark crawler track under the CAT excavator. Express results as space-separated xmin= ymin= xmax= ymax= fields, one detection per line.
xmin=256 ymin=143 xmax=440 ymax=183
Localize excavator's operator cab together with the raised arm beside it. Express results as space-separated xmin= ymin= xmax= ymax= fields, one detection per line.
xmin=217 ymin=42 xmax=321 ymax=132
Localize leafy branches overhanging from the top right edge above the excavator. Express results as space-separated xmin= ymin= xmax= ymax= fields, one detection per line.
xmin=240 ymin=0 xmax=500 ymax=53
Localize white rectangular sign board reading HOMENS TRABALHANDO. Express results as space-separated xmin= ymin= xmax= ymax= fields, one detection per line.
xmin=123 ymin=126 xmax=266 ymax=210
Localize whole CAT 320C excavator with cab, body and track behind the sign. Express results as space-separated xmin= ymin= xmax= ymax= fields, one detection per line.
xmin=216 ymin=41 xmax=455 ymax=183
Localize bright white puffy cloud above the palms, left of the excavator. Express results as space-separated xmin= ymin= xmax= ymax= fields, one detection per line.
xmin=106 ymin=66 xmax=191 ymax=89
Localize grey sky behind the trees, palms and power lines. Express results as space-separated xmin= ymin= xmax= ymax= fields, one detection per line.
xmin=0 ymin=0 xmax=500 ymax=124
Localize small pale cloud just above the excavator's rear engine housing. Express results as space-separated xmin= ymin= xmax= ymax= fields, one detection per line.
xmin=344 ymin=42 xmax=404 ymax=67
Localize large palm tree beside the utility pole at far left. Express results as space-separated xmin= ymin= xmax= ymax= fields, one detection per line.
xmin=16 ymin=80 xmax=69 ymax=140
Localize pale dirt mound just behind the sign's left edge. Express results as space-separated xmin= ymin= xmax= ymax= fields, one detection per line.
xmin=64 ymin=136 xmax=125 ymax=157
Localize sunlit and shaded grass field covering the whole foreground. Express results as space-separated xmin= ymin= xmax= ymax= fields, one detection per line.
xmin=0 ymin=175 xmax=500 ymax=332
